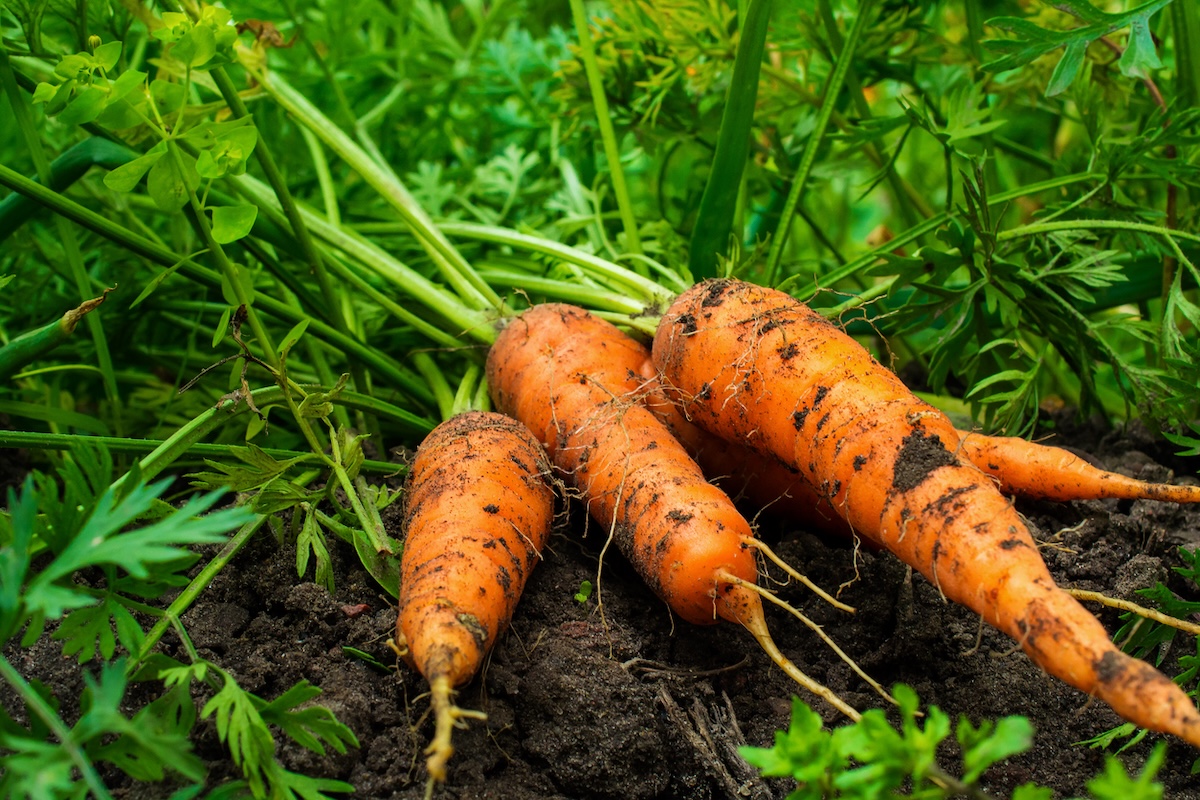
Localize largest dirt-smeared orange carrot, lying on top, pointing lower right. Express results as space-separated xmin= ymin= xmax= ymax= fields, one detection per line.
xmin=653 ymin=281 xmax=1200 ymax=746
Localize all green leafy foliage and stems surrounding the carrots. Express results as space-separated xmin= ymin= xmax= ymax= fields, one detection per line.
xmin=0 ymin=0 xmax=1200 ymax=798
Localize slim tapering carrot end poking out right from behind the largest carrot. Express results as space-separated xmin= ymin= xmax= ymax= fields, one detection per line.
xmin=959 ymin=431 xmax=1200 ymax=503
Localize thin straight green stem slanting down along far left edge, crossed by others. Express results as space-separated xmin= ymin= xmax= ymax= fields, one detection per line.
xmin=0 ymin=48 xmax=122 ymax=431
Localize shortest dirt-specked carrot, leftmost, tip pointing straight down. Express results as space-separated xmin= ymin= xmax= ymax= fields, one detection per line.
xmin=396 ymin=411 xmax=554 ymax=787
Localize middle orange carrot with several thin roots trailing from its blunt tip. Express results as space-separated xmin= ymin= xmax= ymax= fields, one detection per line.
xmin=487 ymin=305 xmax=873 ymax=718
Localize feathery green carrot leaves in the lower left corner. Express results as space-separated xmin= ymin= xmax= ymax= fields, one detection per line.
xmin=0 ymin=445 xmax=356 ymax=798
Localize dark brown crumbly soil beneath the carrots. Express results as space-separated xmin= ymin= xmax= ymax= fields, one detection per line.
xmin=7 ymin=419 xmax=1200 ymax=800
